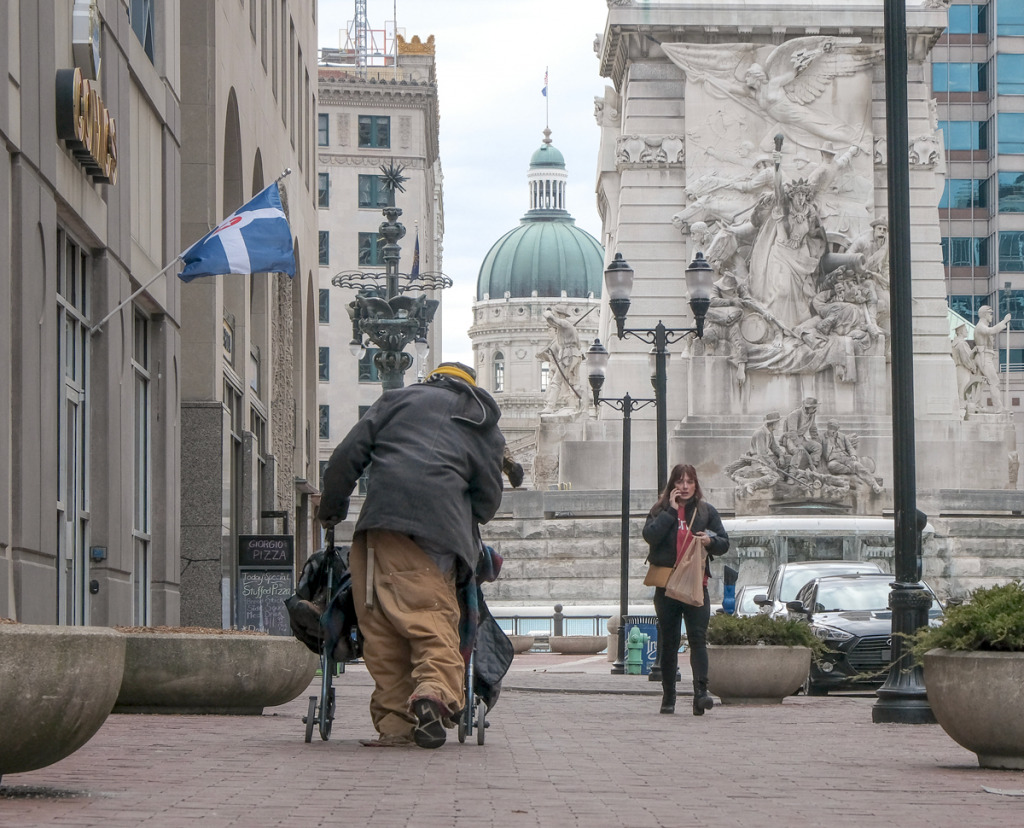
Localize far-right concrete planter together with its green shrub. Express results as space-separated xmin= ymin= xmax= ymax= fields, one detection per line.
xmin=912 ymin=581 xmax=1024 ymax=770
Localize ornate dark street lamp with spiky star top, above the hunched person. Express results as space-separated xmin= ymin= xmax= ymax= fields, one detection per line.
xmin=331 ymin=164 xmax=452 ymax=391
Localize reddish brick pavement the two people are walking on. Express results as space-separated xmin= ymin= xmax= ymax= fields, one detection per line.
xmin=0 ymin=654 xmax=1024 ymax=828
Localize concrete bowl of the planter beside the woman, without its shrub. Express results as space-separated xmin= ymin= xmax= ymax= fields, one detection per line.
xmin=708 ymin=645 xmax=811 ymax=704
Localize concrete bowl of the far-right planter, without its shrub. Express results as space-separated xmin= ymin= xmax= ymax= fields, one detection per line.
xmin=925 ymin=650 xmax=1024 ymax=771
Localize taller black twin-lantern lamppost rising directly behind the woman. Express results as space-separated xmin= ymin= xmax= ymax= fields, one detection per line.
xmin=604 ymin=252 xmax=715 ymax=682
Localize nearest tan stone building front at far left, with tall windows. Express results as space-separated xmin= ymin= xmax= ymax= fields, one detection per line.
xmin=0 ymin=0 xmax=183 ymax=625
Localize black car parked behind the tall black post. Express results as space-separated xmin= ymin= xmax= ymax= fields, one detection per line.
xmin=786 ymin=572 xmax=942 ymax=696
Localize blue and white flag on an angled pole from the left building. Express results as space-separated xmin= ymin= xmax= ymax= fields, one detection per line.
xmin=178 ymin=181 xmax=295 ymax=281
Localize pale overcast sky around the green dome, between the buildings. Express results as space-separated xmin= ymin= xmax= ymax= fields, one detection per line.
xmin=318 ymin=0 xmax=607 ymax=364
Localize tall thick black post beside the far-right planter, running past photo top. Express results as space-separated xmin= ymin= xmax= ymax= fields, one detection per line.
xmin=871 ymin=0 xmax=935 ymax=725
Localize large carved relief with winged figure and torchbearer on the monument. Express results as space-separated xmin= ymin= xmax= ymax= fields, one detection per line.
xmin=663 ymin=36 xmax=888 ymax=384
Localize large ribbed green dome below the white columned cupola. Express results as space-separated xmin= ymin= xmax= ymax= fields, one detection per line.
xmin=476 ymin=214 xmax=604 ymax=301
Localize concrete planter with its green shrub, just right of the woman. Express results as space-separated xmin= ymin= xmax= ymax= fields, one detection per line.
xmin=708 ymin=615 xmax=824 ymax=704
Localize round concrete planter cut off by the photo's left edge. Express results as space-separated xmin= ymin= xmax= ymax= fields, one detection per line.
xmin=0 ymin=624 xmax=125 ymax=776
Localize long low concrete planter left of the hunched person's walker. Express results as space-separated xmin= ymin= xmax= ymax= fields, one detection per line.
xmin=114 ymin=633 xmax=319 ymax=715
